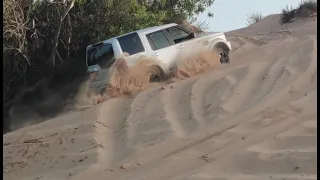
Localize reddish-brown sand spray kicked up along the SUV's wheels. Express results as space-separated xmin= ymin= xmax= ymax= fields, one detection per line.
xmin=98 ymin=51 xmax=220 ymax=100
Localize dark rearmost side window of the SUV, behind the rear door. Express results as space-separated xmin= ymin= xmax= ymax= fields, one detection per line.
xmin=118 ymin=33 xmax=144 ymax=55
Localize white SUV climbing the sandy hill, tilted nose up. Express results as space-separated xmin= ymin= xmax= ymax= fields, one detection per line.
xmin=86 ymin=23 xmax=231 ymax=79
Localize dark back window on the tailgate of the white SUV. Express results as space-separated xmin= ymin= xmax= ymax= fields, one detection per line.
xmin=87 ymin=43 xmax=115 ymax=69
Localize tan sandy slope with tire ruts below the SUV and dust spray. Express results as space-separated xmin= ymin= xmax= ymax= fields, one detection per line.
xmin=4 ymin=15 xmax=317 ymax=180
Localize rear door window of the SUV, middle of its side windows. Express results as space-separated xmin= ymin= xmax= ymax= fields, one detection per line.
xmin=147 ymin=30 xmax=171 ymax=50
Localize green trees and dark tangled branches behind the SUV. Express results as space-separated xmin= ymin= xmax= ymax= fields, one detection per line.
xmin=3 ymin=0 xmax=214 ymax=102
